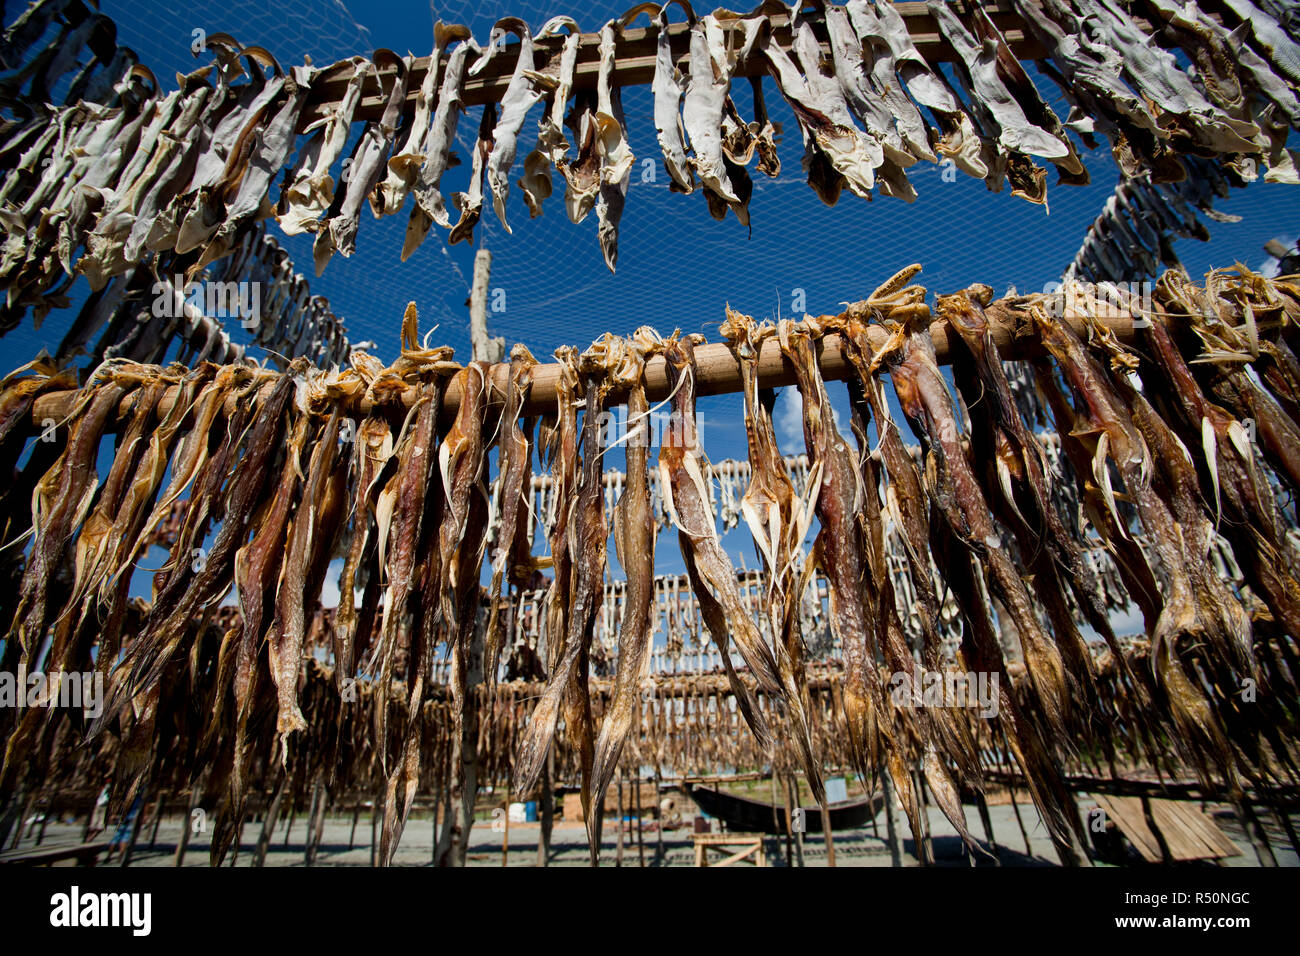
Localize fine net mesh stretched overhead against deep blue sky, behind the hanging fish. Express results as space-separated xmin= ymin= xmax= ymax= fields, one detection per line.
xmin=20 ymin=0 xmax=1279 ymax=374
